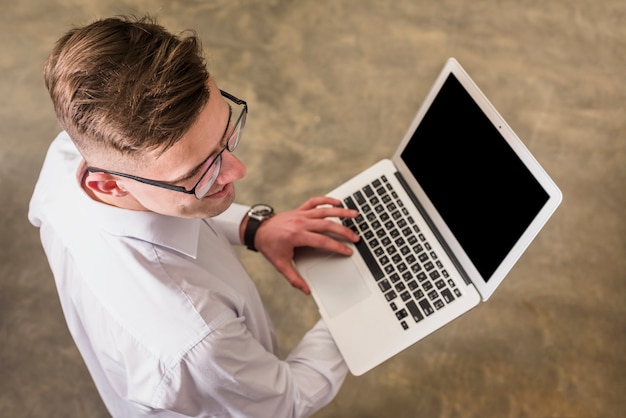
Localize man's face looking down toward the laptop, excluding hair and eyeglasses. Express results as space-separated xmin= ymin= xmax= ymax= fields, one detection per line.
xmin=85 ymin=79 xmax=246 ymax=218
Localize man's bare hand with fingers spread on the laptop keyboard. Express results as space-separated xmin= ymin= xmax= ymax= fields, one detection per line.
xmin=254 ymin=197 xmax=360 ymax=295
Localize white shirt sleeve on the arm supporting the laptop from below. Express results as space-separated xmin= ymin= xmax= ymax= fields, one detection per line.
xmin=152 ymin=314 xmax=348 ymax=418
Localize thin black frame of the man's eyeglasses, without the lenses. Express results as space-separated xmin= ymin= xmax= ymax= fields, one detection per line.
xmin=87 ymin=90 xmax=248 ymax=200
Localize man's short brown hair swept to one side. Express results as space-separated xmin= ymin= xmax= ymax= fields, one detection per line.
xmin=44 ymin=16 xmax=209 ymax=162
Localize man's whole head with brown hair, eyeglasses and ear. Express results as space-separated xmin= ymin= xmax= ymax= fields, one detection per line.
xmin=44 ymin=17 xmax=247 ymax=217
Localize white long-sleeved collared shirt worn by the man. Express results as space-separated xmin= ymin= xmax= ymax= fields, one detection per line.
xmin=29 ymin=132 xmax=347 ymax=418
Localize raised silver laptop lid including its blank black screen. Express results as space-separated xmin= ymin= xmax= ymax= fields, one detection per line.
xmin=392 ymin=58 xmax=562 ymax=300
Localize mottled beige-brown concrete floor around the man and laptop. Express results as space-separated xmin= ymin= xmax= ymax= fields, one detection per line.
xmin=0 ymin=0 xmax=626 ymax=418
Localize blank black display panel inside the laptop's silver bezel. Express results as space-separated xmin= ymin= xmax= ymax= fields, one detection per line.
xmin=401 ymin=74 xmax=549 ymax=281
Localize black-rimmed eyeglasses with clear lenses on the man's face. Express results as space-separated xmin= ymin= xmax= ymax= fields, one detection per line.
xmin=87 ymin=90 xmax=248 ymax=200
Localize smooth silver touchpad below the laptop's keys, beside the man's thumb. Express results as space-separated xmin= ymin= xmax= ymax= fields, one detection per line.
xmin=307 ymin=256 xmax=370 ymax=318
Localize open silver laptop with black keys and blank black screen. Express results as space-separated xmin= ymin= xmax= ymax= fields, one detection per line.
xmin=295 ymin=58 xmax=562 ymax=375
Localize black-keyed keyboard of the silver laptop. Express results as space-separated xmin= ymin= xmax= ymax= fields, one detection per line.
xmin=342 ymin=176 xmax=461 ymax=330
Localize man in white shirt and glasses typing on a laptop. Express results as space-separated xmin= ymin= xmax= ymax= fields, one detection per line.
xmin=29 ymin=14 xmax=358 ymax=418
